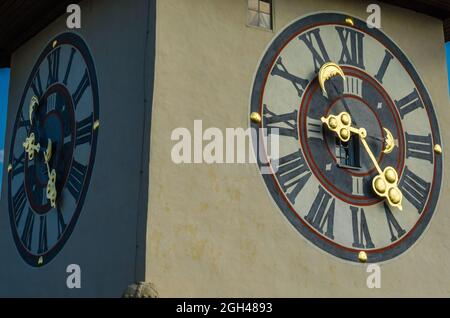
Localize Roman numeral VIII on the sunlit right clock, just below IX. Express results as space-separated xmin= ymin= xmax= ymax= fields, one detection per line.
xmin=276 ymin=151 xmax=311 ymax=204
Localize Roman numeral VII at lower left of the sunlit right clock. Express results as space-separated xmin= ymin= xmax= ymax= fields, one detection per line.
xmin=305 ymin=186 xmax=335 ymax=239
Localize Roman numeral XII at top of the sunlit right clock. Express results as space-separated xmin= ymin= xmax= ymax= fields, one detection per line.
xmin=336 ymin=27 xmax=366 ymax=69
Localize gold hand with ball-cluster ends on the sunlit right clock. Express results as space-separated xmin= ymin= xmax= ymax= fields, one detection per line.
xmin=321 ymin=112 xmax=403 ymax=210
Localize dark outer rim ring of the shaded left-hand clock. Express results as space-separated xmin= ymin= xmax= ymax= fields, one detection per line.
xmin=8 ymin=32 xmax=99 ymax=267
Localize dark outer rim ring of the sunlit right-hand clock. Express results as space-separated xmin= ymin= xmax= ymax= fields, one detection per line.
xmin=250 ymin=13 xmax=443 ymax=263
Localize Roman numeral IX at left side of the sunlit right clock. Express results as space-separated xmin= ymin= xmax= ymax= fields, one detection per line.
xmin=264 ymin=105 xmax=298 ymax=139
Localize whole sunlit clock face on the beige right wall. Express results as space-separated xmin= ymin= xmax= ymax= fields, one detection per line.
xmin=251 ymin=13 xmax=442 ymax=262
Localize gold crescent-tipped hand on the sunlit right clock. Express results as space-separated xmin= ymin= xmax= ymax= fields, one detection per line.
xmin=318 ymin=62 xmax=395 ymax=154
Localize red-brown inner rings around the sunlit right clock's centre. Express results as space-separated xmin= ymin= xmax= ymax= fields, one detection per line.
xmin=298 ymin=66 xmax=405 ymax=206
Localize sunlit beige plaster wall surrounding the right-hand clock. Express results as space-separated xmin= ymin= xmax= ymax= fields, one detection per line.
xmin=146 ymin=0 xmax=450 ymax=297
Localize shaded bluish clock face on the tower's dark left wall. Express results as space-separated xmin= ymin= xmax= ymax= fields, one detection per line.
xmin=8 ymin=33 xmax=99 ymax=267
